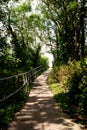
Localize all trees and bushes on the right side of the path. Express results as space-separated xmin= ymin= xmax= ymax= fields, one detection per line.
xmin=39 ymin=0 xmax=87 ymax=126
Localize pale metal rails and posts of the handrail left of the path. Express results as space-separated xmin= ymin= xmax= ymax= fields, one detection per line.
xmin=0 ymin=65 xmax=43 ymax=103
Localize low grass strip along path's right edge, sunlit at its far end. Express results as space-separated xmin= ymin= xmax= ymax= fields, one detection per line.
xmin=49 ymin=83 xmax=85 ymax=124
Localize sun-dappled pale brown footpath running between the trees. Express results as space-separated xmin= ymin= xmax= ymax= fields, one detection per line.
xmin=8 ymin=70 xmax=81 ymax=130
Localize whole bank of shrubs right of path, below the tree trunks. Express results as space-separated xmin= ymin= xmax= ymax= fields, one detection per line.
xmin=48 ymin=58 xmax=87 ymax=124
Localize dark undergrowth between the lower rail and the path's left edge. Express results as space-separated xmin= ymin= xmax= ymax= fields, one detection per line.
xmin=0 ymin=83 xmax=33 ymax=129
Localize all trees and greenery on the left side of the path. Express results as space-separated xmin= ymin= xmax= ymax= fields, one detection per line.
xmin=0 ymin=0 xmax=48 ymax=126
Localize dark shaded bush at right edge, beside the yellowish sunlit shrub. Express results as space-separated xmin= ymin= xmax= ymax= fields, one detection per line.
xmin=67 ymin=58 xmax=87 ymax=118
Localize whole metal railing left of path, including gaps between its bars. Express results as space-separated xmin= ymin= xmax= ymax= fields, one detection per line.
xmin=0 ymin=65 xmax=44 ymax=103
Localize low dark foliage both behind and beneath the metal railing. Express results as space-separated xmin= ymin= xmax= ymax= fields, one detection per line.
xmin=0 ymin=63 xmax=47 ymax=128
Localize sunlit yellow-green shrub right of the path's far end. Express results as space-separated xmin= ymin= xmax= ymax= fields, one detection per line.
xmin=48 ymin=60 xmax=80 ymax=89
